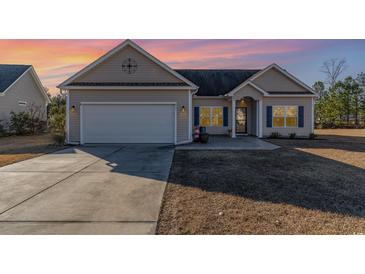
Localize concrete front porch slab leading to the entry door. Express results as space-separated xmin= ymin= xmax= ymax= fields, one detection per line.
xmin=175 ymin=135 xmax=279 ymax=150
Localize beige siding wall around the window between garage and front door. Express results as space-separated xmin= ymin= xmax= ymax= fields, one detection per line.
xmin=192 ymin=97 xmax=232 ymax=135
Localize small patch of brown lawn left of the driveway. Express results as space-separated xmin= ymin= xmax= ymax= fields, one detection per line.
xmin=0 ymin=134 xmax=62 ymax=167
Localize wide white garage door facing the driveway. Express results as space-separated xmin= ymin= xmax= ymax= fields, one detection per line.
xmin=81 ymin=103 xmax=175 ymax=143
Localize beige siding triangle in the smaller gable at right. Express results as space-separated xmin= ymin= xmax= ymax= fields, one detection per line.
xmin=253 ymin=68 xmax=307 ymax=92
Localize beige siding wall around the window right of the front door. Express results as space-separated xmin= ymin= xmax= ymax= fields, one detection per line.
xmin=263 ymin=97 xmax=313 ymax=137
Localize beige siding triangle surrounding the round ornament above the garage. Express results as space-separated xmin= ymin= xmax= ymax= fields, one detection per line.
xmin=73 ymin=46 xmax=182 ymax=83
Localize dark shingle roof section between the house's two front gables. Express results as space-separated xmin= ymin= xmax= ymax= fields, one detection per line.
xmin=175 ymin=69 xmax=260 ymax=96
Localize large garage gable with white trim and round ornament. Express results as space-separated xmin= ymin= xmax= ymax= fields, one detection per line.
xmin=60 ymin=40 xmax=196 ymax=89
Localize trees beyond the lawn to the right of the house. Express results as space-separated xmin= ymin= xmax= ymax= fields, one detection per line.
xmin=313 ymin=59 xmax=365 ymax=128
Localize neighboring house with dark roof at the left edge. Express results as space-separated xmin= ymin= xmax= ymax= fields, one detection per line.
xmin=0 ymin=64 xmax=49 ymax=126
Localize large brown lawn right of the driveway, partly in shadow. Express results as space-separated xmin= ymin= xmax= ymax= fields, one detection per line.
xmin=157 ymin=130 xmax=365 ymax=234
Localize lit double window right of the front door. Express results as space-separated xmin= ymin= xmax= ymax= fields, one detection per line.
xmin=272 ymin=106 xmax=298 ymax=127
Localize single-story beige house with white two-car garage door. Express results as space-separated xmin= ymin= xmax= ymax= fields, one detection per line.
xmin=59 ymin=40 xmax=316 ymax=144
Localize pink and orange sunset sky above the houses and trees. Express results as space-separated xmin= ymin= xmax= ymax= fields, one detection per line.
xmin=0 ymin=39 xmax=365 ymax=94
